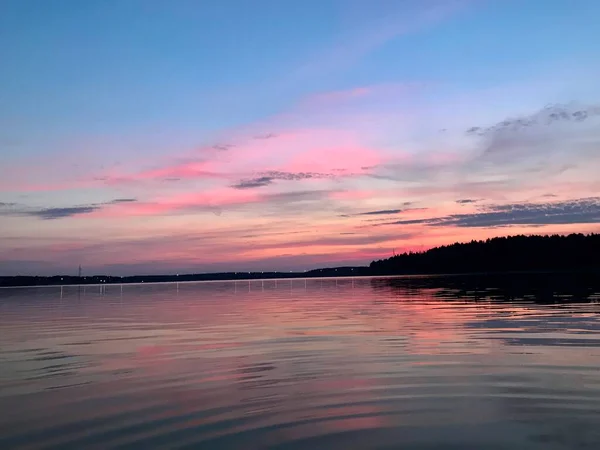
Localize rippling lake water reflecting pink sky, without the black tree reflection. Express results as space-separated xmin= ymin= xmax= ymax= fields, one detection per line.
xmin=0 ymin=278 xmax=600 ymax=450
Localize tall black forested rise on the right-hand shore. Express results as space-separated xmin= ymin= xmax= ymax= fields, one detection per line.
xmin=370 ymin=234 xmax=600 ymax=275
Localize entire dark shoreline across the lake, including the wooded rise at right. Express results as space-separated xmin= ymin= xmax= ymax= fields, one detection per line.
xmin=0 ymin=234 xmax=600 ymax=287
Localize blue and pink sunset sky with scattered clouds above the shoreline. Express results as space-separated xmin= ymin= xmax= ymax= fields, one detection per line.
xmin=0 ymin=0 xmax=600 ymax=275
